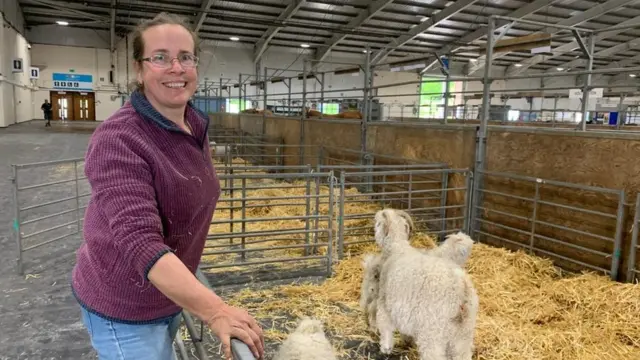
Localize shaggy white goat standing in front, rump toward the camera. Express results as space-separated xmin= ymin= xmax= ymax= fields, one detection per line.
xmin=375 ymin=209 xmax=479 ymax=360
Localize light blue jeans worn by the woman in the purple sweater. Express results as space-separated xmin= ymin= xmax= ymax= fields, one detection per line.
xmin=81 ymin=307 xmax=182 ymax=360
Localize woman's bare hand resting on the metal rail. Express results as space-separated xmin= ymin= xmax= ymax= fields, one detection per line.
xmin=207 ymin=304 xmax=264 ymax=360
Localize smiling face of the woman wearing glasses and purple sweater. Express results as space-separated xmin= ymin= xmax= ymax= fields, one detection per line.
xmin=138 ymin=24 xmax=198 ymax=110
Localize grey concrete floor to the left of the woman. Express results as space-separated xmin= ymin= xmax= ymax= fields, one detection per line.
xmin=0 ymin=121 xmax=97 ymax=360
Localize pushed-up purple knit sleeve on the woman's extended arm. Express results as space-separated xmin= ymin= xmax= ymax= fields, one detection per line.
xmin=85 ymin=123 xmax=171 ymax=280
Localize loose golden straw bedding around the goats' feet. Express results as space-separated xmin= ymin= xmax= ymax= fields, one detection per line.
xmin=199 ymin=162 xmax=640 ymax=360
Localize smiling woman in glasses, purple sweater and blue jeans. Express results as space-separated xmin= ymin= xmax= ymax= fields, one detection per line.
xmin=72 ymin=14 xmax=264 ymax=360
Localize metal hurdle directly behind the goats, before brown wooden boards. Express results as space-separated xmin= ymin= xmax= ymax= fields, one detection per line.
xmin=337 ymin=169 xmax=471 ymax=258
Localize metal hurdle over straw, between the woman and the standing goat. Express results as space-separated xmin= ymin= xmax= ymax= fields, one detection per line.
xmin=201 ymin=172 xmax=335 ymax=286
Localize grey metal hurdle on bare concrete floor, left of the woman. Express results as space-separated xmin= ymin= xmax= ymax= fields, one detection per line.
xmin=11 ymin=159 xmax=91 ymax=274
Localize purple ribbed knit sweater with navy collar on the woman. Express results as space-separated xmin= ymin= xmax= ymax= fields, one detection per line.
xmin=72 ymin=92 xmax=220 ymax=324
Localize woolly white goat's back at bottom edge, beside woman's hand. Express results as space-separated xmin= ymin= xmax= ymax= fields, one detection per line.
xmin=273 ymin=317 xmax=337 ymax=360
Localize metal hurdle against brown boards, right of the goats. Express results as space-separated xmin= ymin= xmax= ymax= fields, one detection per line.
xmin=472 ymin=171 xmax=625 ymax=279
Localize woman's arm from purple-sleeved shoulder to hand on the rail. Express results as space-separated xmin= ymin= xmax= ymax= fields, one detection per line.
xmin=85 ymin=122 xmax=264 ymax=359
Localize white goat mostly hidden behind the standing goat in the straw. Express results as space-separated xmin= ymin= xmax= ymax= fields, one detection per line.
xmin=360 ymin=231 xmax=473 ymax=334
